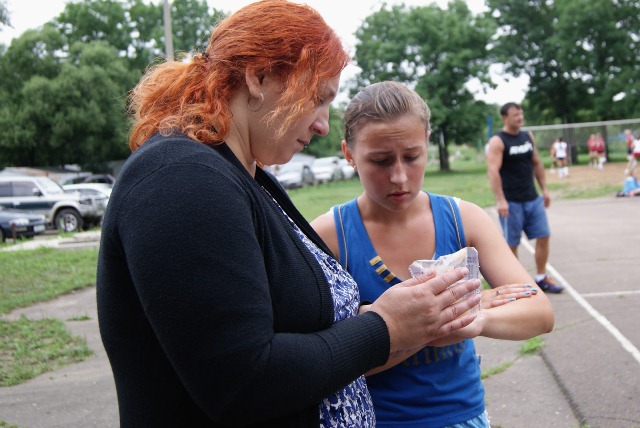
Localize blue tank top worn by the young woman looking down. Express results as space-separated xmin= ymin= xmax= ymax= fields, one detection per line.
xmin=333 ymin=193 xmax=485 ymax=428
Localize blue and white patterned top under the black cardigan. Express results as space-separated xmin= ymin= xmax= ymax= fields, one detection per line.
xmin=276 ymin=202 xmax=376 ymax=428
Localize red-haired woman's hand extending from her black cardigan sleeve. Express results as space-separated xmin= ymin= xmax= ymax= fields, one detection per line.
xmin=367 ymin=267 xmax=481 ymax=355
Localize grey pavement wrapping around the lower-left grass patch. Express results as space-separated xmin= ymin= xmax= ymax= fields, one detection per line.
xmin=0 ymin=287 xmax=120 ymax=428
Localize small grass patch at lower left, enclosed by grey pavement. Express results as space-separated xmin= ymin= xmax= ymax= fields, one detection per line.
xmin=0 ymin=318 xmax=93 ymax=386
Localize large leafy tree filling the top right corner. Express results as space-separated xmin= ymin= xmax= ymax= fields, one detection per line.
xmin=487 ymin=0 xmax=640 ymax=123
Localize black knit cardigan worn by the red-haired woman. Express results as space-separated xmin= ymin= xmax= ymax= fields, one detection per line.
xmin=97 ymin=135 xmax=390 ymax=427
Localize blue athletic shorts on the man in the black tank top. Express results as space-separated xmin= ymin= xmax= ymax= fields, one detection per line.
xmin=500 ymin=196 xmax=550 ymax=247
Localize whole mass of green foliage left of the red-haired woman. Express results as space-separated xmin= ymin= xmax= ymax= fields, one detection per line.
xmin=0 ymin=0 xmax=223 ymax=170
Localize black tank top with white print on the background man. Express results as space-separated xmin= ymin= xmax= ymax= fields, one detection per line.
xmin=498 ymin=131 xmax=538 ymax=202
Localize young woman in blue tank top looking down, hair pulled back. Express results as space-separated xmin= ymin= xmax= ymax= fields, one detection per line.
xmin=312 ymin=82 xmax=554 ymax=428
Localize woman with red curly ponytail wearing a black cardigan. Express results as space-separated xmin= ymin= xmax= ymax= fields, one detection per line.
xmin=97 ymin=0 xmax=478 ymax=427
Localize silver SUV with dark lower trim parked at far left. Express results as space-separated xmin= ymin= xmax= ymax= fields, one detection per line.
xmin=0 ymin=176 xmax=104 ymax=232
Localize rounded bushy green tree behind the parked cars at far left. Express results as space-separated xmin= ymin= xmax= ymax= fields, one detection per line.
xmin=0 ymin=33 xmax=134 ymax=166
